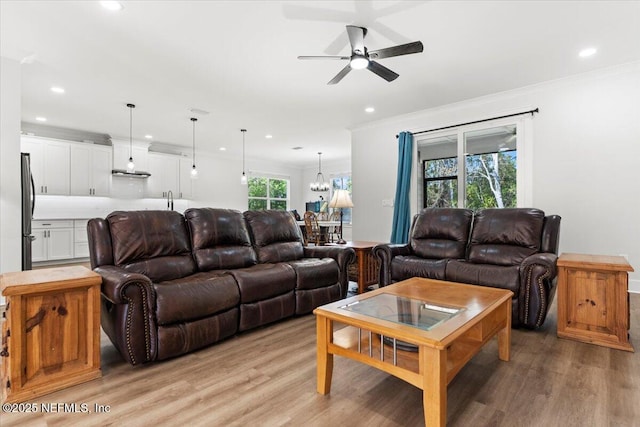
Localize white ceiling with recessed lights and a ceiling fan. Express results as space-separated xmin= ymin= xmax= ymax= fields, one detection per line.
xmin=0 ymin=0 xmax=640 ymax=166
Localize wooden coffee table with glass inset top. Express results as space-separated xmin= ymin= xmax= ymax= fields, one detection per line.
xmin=314 ymin=278 xmax=513 ymax=426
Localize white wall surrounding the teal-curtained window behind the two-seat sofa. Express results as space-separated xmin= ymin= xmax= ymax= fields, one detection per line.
xmin=351 ymin=62 xmax=640 ymax=292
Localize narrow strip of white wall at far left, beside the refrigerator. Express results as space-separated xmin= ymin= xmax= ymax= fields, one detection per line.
xmin=0 ymin=57 xmax=22 ymax=276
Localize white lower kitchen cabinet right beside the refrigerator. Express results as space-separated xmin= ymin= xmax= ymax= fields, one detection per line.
xmin=31 ymin=220 xmax=74 ymax=262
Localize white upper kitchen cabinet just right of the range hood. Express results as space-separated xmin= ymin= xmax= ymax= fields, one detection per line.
xmin=147 ymin=153 xmax=180 ymax=199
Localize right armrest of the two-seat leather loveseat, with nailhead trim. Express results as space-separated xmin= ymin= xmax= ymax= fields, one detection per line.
xmin=518 ymin=252 xmax=558 ymax=328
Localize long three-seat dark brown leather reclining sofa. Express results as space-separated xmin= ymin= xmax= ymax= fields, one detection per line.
xmin=87 ymin=208 xmax=355 ymax=365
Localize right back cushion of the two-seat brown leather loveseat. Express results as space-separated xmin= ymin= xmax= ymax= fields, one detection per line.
xmin=467 ymin=208 xmax=544 ymax=265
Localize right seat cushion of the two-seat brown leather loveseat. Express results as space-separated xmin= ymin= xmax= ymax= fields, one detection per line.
xmin=446 ymin=260 xmax=520 ymax=297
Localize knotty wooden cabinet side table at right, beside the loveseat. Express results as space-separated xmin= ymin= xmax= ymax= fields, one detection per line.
xmin=558 ymin=253 xmax=633 ymax=351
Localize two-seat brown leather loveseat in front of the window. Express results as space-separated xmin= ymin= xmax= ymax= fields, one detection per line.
xmin=373 ymin=208 xmax=560 ymax=328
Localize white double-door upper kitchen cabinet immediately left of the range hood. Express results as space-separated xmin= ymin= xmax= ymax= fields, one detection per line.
xmin=70 ymin=144 xmax=112 ymax=196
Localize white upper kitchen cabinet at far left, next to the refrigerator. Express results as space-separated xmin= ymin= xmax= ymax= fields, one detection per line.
xmin=21 ymin=137 xmax=70 ymax=196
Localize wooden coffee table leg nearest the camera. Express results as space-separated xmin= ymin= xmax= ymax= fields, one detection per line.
xmin=419 ymin=346 xmax=447 ymax=427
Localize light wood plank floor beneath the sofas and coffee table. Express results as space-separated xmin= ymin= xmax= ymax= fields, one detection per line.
xmin=0 ymin=294 xmax=640 ymax=427
